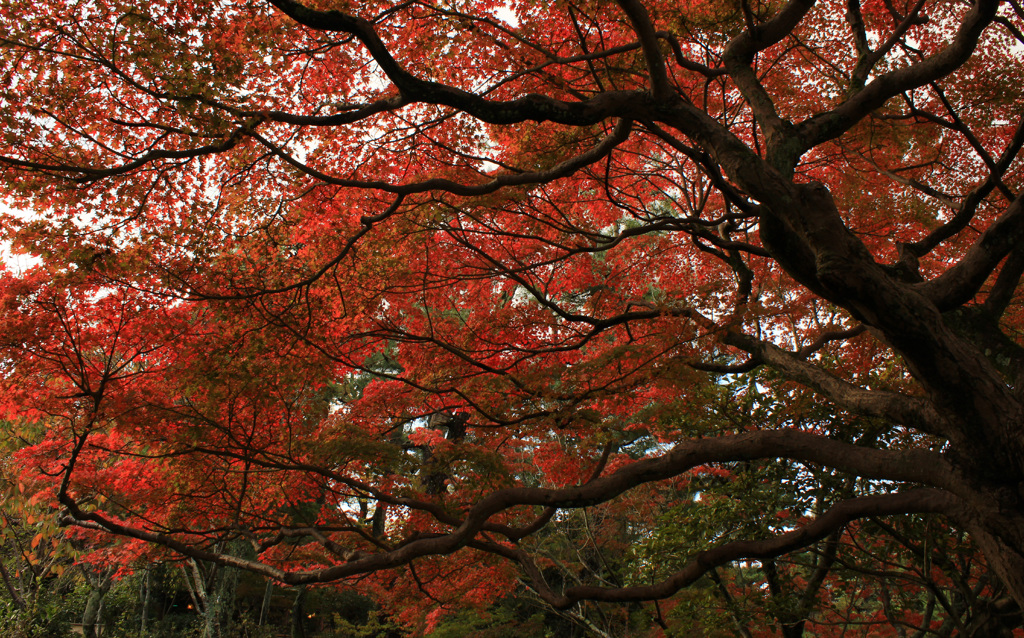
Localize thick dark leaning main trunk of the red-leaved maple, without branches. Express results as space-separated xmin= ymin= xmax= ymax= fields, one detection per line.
xmin=753 ymin=175 xmax=1024 ymax=608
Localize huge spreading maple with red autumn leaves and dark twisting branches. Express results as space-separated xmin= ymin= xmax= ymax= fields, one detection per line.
xmin=0 ymin=0 xmax=1024 ymax=627
